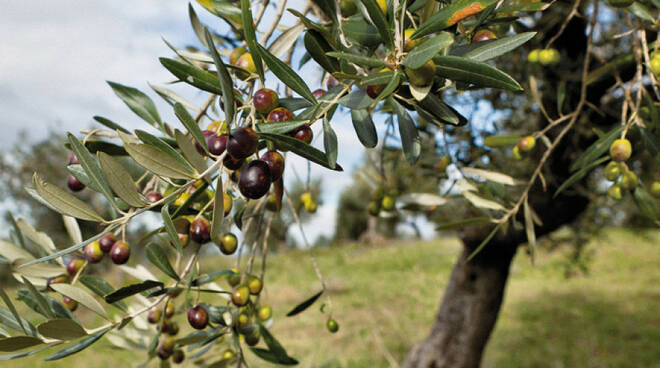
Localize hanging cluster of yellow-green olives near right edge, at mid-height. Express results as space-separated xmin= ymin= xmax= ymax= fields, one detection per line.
xmin=603 ymin=138 xmax=639 ymax=201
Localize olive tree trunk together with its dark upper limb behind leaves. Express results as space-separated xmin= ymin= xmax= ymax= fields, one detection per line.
xmin=402 ymin=2 xmax=640 ymax=368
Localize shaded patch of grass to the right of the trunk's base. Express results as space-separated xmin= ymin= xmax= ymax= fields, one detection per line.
xmin=483 ymin=292 xmax=660 ymax=368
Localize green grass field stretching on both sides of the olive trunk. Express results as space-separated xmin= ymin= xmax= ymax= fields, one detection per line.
xmin=0 ymin=231 xmax=660 ymax=368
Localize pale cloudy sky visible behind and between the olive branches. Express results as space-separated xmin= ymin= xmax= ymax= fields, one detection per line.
xmin=0 ymin=0 xmax=438 ymax=241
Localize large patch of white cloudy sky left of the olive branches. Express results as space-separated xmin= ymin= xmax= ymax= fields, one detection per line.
xmin=0 ymin=0 xmax=192 ymax=144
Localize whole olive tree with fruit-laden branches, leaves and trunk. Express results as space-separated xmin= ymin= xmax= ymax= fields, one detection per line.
xmin=0 ymin=0 xmax=660 ymax=368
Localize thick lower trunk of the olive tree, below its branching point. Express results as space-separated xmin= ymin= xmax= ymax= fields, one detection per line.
xmin=402 ymin=237 xmax=516 ymax=368
